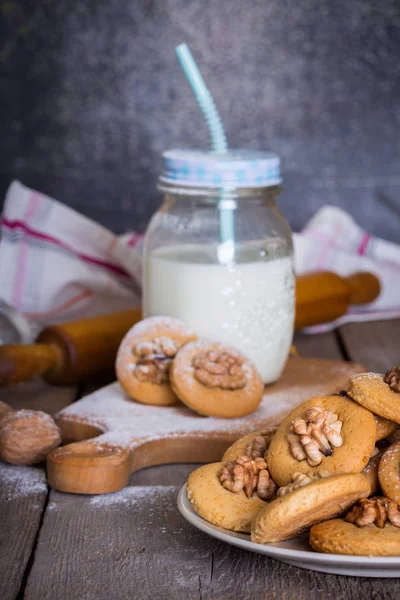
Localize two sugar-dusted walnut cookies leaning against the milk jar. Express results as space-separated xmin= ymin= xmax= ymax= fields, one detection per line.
xmin=116 ymin=317 xmax=264 ymax=418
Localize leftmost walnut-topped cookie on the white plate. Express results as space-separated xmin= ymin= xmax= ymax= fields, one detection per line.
xmin=187 ymin=456 xmax=276 ymax=532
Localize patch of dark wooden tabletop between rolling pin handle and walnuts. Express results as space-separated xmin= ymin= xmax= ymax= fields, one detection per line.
xmin=0 ymin=379 xmax=77 ymax=415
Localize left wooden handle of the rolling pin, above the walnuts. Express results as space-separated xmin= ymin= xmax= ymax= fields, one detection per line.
xmin=0 ymin=344 xmax=61 ymax=386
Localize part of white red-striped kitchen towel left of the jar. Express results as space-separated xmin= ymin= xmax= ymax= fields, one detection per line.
xmin=0 ymin=181 xmax=142 ymax=328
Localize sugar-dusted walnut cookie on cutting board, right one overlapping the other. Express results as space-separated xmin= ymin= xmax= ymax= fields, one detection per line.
xmin=170 ymin=340 xmax=264 ymax=419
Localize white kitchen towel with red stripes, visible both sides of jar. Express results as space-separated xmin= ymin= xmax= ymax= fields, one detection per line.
xmin=0 ymin=181 xmax=400 ymax=331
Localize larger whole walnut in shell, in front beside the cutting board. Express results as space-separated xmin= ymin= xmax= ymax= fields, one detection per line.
xmin=0 ymin=409 xmax=61 ymax=465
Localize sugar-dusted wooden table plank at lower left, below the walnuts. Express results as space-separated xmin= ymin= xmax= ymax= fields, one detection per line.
xmin=0 ymin=461 xmax=48 ymax=600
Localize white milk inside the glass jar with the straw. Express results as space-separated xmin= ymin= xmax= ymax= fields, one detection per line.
xmin=143 ymin=246 xmax=294 ymax=383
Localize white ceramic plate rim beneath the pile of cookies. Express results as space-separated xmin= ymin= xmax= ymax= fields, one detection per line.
xmin=178 ymin=484 xmax=400 ymax=577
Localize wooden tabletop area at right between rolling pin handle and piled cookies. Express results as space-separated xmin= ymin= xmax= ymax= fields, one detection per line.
xmin=339 ymin=320 xmax=400 ymax=373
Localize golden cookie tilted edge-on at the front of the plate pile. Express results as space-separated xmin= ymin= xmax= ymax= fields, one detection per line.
xmin=251 ymin=473 xmax=370 ymax=544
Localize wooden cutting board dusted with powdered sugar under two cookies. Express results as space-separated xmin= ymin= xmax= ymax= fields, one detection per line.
xmin=47 ymin=358 xmax=365 ymax=494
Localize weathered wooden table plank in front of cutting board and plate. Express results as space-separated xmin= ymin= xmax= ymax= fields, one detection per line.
xmin=25 ymin=486 xmax=400 ymax=600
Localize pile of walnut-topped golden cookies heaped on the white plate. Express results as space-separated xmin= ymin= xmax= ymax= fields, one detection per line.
xmin=187 ymin=367 xmax=400 ymax=556
